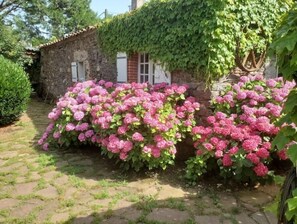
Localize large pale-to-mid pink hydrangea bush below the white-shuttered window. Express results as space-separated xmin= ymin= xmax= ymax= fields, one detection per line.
xmin=39 ymin=81 xmax=199 ymax=170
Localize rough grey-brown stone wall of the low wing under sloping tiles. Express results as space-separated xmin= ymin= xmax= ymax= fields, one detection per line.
xmin=40 ymin=29 xmax=117 ymax=98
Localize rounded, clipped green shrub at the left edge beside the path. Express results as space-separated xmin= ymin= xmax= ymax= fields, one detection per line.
xmin=0 ymin=56 xmax=31 ymax=125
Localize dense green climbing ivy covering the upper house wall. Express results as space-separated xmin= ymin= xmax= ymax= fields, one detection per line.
xmin=99 ymin=0 xmax=291 ymax=82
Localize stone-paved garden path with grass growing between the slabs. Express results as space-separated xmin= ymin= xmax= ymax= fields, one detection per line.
xmin=0 ymin=99 xmax=279 ymax=224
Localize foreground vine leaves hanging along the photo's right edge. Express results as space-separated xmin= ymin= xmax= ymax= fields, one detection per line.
xmin=271 ymin=2 xmax=297 ymax=223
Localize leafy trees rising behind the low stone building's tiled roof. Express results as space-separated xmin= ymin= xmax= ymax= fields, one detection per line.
xmin=0 ymin=0 xmax=100 ymax=64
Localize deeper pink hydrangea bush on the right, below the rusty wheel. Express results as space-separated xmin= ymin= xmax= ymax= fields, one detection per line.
xmin=187 ymin=74 xmax=295 ymax=182
